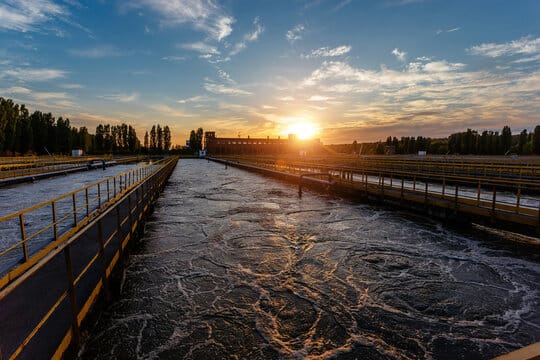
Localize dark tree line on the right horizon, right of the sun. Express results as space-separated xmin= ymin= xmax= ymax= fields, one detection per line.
xmin=329 ymin=125 xmax=540 ymax=155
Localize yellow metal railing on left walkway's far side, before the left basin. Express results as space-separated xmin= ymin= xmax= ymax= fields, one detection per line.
xmin=0 ymin=162 xmax=167 ymax=289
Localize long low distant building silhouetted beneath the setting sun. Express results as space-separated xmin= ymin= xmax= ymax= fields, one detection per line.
xmin=204 ymin=131 xmax=322 ymax=156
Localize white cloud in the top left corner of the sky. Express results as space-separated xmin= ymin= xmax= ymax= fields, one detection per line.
xmin=0 ymin=0 xmax=68 ymax=32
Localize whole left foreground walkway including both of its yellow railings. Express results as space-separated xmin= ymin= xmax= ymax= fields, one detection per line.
xmin=0 ymin=157 xmax=178 ymax=360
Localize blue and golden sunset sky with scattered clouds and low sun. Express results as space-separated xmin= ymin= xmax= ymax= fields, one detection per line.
xmin=0 ymin=0 xmax=540 ymax=144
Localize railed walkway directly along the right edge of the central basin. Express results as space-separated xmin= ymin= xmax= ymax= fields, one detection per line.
xmin=213 ymin=157 xmax=540 ymax=231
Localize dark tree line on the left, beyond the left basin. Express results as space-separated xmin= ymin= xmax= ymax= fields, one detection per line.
xmin=0 ymin=97 xmax=171 ymax=155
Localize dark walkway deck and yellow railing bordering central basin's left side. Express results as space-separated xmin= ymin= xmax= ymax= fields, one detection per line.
xmin=0 ymin=158 xmax=177 ymax=360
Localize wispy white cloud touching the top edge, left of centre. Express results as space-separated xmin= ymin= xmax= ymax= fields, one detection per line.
xmin=131 ymin=0 xmax=235 ymax=41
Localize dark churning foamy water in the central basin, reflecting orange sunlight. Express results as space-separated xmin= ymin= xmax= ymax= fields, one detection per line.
xmin=80 ymin=160 xmax=540 ymax=359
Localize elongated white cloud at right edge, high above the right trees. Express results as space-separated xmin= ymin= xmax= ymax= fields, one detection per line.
xmin=467 ymin=36 xmax=540 ymax=58
